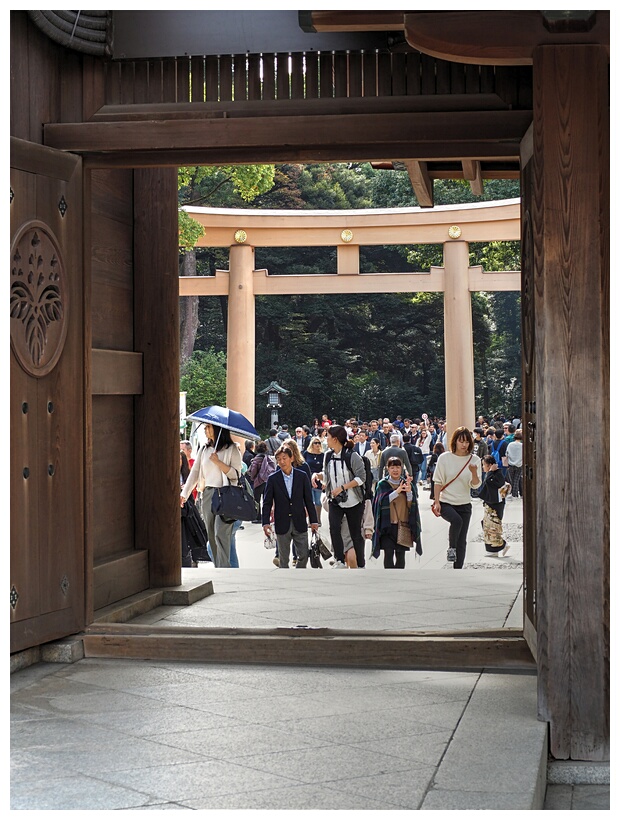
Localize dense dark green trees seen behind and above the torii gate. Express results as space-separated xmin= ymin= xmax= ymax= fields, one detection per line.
xmin=179 ymin=164 xmax=521 ymax=429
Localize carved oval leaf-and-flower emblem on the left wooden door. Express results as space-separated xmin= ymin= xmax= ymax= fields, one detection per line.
xmin=11 ymin=221 xmax=68 ymax=377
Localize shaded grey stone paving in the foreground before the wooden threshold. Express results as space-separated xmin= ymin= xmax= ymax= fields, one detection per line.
xmin=11 ymin=658 xmax=545 ymax=812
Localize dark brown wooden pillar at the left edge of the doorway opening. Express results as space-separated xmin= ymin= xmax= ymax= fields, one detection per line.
xmin=134 ymin=168 xmax=181 ymax=587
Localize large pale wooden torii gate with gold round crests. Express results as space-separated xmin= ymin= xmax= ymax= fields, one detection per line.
xmin=179 ymin=199 xmax=521 ymax=431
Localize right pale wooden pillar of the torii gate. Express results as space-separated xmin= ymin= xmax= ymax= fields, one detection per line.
xmin=443 ymin=241 xmax=476 ymax=441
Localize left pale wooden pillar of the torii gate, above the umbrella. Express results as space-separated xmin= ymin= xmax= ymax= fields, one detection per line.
xmin=226 ymin=245 xmax=256 ymax=423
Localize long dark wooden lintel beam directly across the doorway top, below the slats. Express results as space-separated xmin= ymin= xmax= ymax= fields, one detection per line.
xmin=44 ymin=111 xmax=532 ymax=166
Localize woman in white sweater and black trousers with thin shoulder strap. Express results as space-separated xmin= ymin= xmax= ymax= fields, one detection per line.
xmin=432 ymin=427 xmax=482 ymax=569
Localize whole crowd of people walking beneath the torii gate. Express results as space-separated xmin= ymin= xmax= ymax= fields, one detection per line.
xmin=181 ymin=414 xmax=523 ymax=569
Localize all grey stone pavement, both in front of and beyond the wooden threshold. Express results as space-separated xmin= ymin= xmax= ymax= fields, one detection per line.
xmin=11 ymin=502 xmax=609 ymax=812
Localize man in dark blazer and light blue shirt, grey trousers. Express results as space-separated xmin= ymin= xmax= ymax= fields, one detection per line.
xmin=262 ymin=444 xmax=319 ymax=569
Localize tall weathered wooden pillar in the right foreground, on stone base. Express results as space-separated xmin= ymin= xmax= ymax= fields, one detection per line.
xmin=532 ymin=45 xmax=614 ymax=760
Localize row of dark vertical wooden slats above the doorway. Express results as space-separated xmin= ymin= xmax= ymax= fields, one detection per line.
xmin=106 ymin=50 xmax=531 ymax=108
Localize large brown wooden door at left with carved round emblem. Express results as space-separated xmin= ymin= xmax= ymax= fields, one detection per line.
xmin=10 ymin=139 xmax=85 ymax=652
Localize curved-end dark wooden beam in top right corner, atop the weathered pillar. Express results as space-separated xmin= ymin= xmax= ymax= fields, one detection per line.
xmin=405 ymin=11 xmax=609 ymax=65
